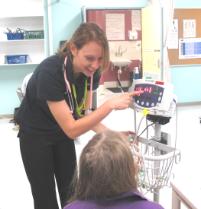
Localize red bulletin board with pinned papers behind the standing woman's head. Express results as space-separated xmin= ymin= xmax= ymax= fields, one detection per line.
xmin=82 ymin=7 xmax=142 ymax=87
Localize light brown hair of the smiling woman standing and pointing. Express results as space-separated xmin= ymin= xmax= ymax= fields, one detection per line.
xmin=58 ymin=22 xmax=110 ymax=70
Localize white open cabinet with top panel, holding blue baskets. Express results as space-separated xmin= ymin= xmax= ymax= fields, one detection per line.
xmin=0 ymin=0 xmax=45 ymax=66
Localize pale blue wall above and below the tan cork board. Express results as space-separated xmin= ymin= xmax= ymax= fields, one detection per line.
xmin=171 ymin=0 xmax=201 ymax=103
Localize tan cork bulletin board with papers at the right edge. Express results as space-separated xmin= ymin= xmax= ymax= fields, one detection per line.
xmin=168 ymin=9 xmax=201 ymax=65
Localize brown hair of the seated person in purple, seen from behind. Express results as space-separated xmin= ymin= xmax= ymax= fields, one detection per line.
xmin=70 ymin=131 xmax=137 ymax=201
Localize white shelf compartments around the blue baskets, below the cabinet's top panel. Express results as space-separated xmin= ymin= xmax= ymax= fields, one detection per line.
xmin=0 ymin=15 xmax=45 ymax=65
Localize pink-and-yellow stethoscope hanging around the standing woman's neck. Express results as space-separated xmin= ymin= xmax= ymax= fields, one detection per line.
xmin=63 ymin=56 xmax=93 ymax=117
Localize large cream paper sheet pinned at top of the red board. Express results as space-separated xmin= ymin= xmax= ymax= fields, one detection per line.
xmin=105 ymin=13 xmax=125 ymax=41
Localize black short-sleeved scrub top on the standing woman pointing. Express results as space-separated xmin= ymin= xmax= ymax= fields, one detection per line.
xmin=16 ymin=55 xmax=100 ymax=135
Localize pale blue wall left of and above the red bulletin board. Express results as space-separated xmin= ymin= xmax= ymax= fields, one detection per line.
xmin=46 ymin=0 xmax=147 ymax=54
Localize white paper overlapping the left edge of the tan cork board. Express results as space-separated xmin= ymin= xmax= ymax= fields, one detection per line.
xmin=167 ymin=19 xmax=179 ymax=49
